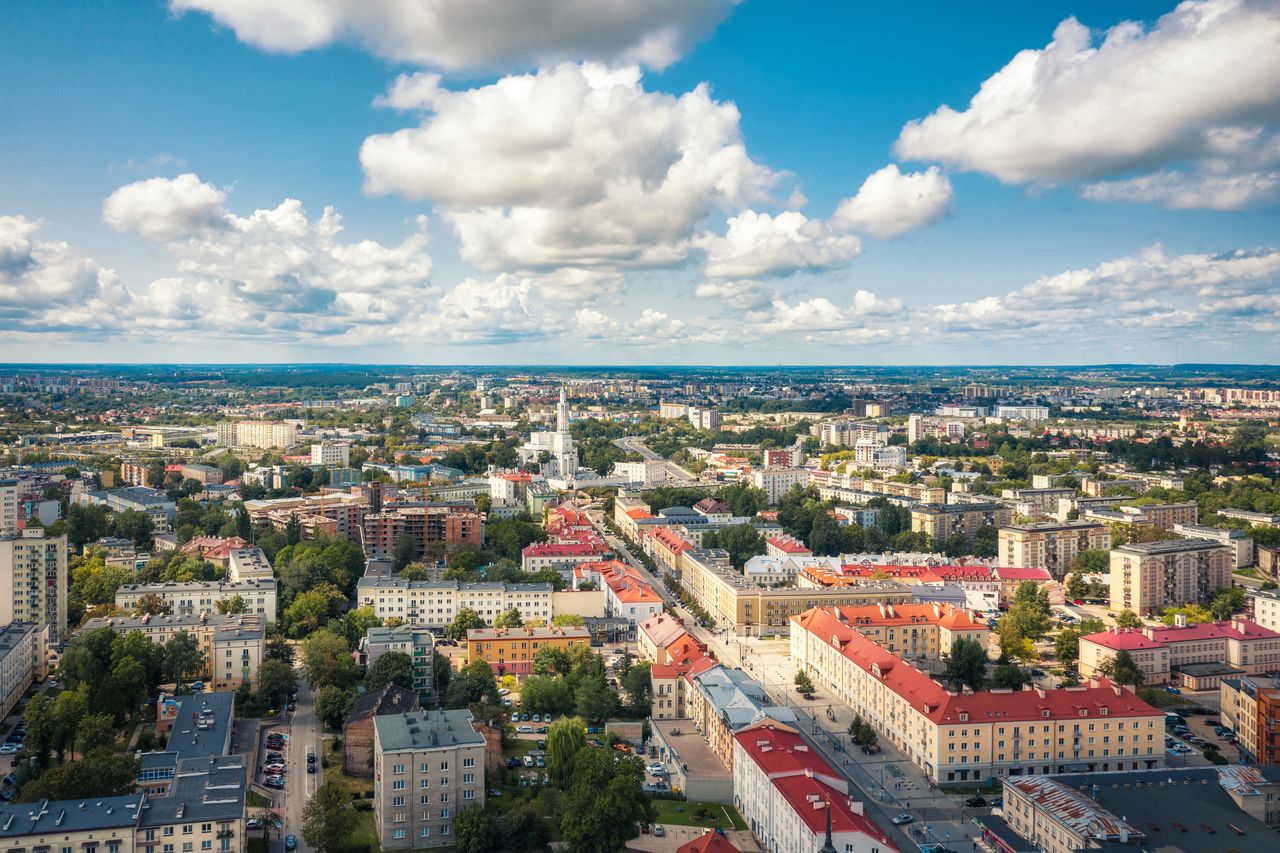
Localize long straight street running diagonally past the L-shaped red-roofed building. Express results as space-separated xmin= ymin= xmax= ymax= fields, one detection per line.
xmin=588 ymin=512 xmax=978 ymax=850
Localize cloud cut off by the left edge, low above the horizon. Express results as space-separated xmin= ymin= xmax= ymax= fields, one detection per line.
xmin=0 ymin=216 xmax=131 ymax=337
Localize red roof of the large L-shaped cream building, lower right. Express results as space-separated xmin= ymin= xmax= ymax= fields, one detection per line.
xmin=791 ymin=608 xmax=1160 ymax=725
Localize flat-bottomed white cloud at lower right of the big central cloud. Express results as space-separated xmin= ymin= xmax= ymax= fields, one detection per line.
xmin=698 ymin=210 xmax=861 ymax=278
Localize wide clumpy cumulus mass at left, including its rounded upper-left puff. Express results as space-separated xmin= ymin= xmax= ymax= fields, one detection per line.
xmin=104 ymin=174 xmax=438 ymax=343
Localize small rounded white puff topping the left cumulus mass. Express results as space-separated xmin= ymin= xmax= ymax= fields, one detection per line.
xmin=102 ymin=172 xmax=227 ymax=240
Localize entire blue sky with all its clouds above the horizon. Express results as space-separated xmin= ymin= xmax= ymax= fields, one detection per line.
xmin=0 ymin=0 xmax=1280 ymax=365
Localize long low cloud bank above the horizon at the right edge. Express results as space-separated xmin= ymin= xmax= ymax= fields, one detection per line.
xmin=920 ymin=246 xmax=1280 ymax=341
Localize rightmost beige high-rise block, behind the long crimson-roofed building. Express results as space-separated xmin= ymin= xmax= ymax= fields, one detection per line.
xmin=1111 ymin=539 xmax=1233 ymax=616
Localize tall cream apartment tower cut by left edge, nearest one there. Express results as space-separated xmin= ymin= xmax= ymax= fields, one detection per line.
xmin=0 ymin=528 xmax=68 ymax=643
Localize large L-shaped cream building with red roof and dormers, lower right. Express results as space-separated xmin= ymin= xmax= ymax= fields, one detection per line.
xmin=791 ymin=604 xmax=1165 ymax=785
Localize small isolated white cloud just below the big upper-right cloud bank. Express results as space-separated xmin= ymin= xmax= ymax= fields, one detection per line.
xmin=831 ymin=163 xmax=951 ymax=237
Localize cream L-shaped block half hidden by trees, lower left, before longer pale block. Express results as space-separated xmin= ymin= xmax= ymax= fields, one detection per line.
xmin=81 ymin=615 xmax=266 ymax=690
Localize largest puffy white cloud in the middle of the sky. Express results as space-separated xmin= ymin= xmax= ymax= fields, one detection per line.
xmin=360 ymin=63 xmax=778 ymax=272
